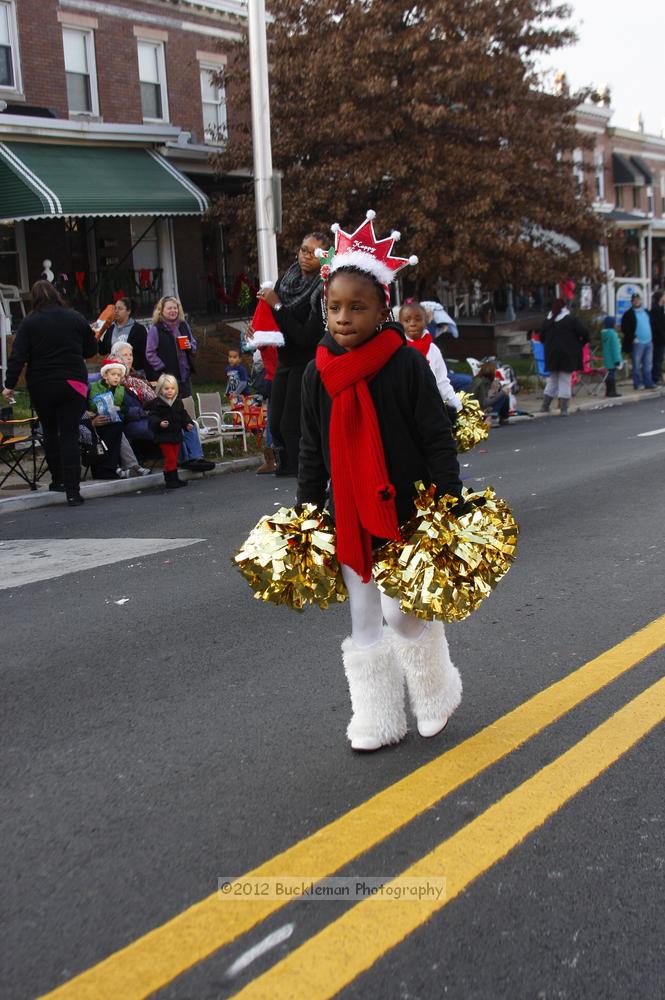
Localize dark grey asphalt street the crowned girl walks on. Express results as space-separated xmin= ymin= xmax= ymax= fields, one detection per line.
xmin=0 ymin=398 xmax=665 ymax=1000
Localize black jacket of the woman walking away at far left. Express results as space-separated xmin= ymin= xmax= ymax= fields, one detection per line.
xmin=5 ymin=306 xmax=97 ymax=389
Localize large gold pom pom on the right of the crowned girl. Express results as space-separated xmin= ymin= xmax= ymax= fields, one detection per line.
xmin=374 ymin=483 xmax=519 ymax=622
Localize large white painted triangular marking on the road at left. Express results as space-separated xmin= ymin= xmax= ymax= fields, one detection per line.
xmin=0 ymin=537 xmax=205 ymax=590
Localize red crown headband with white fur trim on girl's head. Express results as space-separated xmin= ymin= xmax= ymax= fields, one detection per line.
xmin=314 ymin=209 xmax=418 ymax=291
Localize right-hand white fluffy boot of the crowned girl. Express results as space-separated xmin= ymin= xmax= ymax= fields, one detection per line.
xmin=392 ymin=622 xmax=462 ymax=736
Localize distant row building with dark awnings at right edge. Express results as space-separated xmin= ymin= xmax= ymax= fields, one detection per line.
xmin=573 ymin=104 xmax=665 ymax=314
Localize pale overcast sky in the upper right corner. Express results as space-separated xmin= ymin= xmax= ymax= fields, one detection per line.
xmin=546 ymin=0 xmax=665 ymax=135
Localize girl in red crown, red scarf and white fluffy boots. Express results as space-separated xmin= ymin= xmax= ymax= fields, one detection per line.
xmin=298 ymin=214 xmax=462 ymax=751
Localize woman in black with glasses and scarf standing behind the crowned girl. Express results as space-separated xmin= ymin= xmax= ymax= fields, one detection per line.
xmin=258 ymin=232 xmax=330 ymax=476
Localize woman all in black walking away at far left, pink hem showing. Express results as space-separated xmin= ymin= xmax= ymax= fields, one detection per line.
xmin=3 ymin=281 xmax=97 ymax=507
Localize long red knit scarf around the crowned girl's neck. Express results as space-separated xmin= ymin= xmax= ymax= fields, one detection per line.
xmin=316 ymin=329 xmax=402 ymax=583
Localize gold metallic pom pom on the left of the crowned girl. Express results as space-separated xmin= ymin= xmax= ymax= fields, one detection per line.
xmin=233 ymin=504 xmax=347 ymax=611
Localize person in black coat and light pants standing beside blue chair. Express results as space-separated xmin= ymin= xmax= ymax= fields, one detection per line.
xmin=540 ymin=299 xmax=589 ymax=417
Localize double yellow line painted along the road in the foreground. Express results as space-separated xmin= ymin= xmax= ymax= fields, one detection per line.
xmin=40 ymin=616 xmax=665 ymax=1000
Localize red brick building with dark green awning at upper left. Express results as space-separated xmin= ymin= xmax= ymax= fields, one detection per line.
xmin=0 ymin=0 xmax=246 ymax=315
